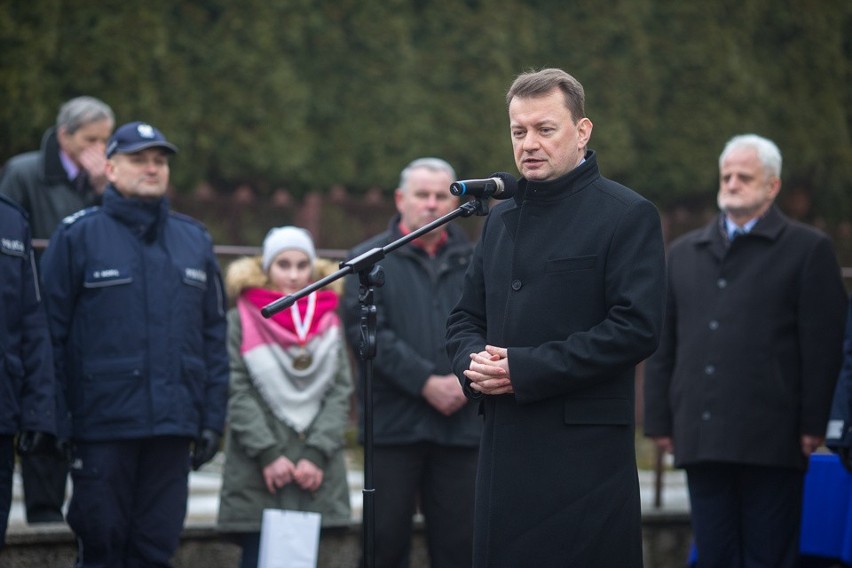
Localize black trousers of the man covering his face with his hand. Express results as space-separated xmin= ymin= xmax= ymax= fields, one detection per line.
xmin=21 ymin=449 xmax=68 ymax=524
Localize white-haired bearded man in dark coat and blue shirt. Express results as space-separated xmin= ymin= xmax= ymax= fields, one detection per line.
xmin=645 ymin=135 xmax=846 ymax=568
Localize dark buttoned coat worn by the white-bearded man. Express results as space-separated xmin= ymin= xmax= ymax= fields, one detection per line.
xmin=645 ymin=206 xmax=846 ymax=469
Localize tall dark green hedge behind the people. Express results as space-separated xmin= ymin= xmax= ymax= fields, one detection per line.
xmin=0 ymin=0 xmax=852 ymax=220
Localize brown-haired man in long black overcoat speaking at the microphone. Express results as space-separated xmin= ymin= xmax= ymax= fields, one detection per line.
xmin=447 ymin=69 xmax=665 ymax=568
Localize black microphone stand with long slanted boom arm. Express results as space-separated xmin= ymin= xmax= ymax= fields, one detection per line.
xmin=260 ymin=197 xmax=488 ymax=568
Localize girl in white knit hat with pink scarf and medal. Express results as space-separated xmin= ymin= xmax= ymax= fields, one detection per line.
xmin=219 ymin=226 xmax=352 ymax=568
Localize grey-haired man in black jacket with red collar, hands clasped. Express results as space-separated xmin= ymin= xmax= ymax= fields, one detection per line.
xmin=344 ymin=158 xmax=480 ymax=568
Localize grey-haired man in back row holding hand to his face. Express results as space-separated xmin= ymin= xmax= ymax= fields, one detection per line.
xmin=0 ymin=96 xmax=115 ymax=524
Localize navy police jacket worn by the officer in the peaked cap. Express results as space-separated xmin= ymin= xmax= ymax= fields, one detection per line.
xmin=41 ymin=187 xmax=228 ymax=441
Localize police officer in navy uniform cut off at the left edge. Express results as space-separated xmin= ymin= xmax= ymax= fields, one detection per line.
xmin=0 ymin=195 xmax=56 ymax=549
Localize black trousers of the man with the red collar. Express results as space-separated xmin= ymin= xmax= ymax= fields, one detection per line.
xmin=362 ymin=442 xmax=478 ymax=568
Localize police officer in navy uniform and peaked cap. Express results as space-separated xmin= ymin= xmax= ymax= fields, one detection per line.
xmin=41 ymin=122 xmax=228 ymax=568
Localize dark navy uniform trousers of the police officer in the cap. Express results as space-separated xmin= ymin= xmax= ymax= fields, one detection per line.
xmin=68 ymin=437 xmax=190 ymax=568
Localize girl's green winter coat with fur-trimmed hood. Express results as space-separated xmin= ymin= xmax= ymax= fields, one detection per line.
xmin=218 ymin=258 xmax=352 ymax=531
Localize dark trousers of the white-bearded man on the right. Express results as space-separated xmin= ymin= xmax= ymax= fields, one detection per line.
xmin=686 ymin=463 xmax=804 ymax=568
